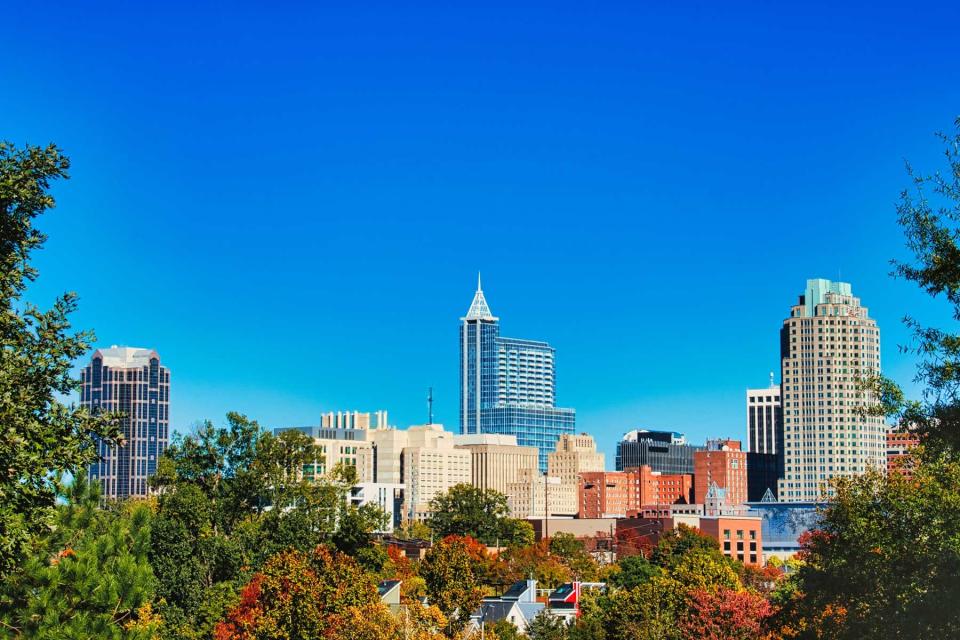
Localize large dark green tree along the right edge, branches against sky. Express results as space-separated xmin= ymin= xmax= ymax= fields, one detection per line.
xmin=773 ymin=118 xmax=960 ymax=639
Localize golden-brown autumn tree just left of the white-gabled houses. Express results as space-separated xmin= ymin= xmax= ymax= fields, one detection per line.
xmin=420 ymin=536 xmax=483 ymax=637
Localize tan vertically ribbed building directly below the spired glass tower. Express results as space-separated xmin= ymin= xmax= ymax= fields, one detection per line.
xmin=453 ymin=433 xmax=538 ymax=494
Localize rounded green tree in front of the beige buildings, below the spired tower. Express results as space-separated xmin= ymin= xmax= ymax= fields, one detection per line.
xmin=429 ymin=484 xmax=533 ymax=546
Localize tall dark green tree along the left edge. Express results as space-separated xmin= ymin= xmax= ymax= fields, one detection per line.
xmin=0 ymin=142 xmax=120 ymax=580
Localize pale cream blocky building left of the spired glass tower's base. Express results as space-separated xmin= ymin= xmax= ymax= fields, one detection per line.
xmin=367 ymin=424 xmax=471 ymax=520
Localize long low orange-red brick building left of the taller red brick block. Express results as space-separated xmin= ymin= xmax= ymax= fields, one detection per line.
xmin=578 ymin=466 xmax=693 ymax=518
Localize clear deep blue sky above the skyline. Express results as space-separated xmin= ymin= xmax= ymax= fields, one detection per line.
xmin=0 ymin=1 xmax=960 ymax=467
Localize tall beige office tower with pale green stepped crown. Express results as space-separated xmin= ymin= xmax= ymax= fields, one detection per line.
xmin=778 ymin=279 xmax=886 ymax=502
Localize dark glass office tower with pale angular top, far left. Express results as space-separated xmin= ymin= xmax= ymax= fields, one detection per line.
xmin=80 ymin=346 xmax=170 ymax=499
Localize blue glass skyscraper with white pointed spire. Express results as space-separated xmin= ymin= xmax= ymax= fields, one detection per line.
xmin=460 ymin=277 xmax=576 ymax=472
